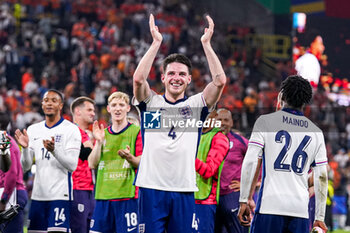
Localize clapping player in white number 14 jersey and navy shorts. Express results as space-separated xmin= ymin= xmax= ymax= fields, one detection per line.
xmin=15 ymin=89 xmax=81 ymax=232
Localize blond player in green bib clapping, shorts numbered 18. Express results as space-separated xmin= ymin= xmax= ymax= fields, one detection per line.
xmin=88 ymin=92 xmax=142 ymax=233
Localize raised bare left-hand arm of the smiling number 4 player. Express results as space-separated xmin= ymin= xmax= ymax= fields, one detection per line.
xmin=133 ymin=14 xmax=163 ymax=102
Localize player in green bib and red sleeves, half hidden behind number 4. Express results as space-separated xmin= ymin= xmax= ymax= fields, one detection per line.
xmin=194 ymin=110 xmax=229 ymax=233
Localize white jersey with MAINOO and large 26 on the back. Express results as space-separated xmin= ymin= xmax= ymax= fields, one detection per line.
xmin=249 ymin=109 xmax=327 ymax=218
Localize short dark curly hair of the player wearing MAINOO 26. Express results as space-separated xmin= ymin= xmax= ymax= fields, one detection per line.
xmin=281 ymin=75 xmax=312 ymax=108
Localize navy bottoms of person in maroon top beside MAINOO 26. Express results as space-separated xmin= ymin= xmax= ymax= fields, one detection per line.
xmin=215 ymin=192 xmax=249 ymax=233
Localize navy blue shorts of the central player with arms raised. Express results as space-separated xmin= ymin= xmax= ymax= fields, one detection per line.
xmin=139 ymin=188 xmax=196 ymax=233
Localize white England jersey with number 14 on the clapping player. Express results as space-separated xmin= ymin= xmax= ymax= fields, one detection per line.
xmin=27 ymin=118 xmax=81 ymax=201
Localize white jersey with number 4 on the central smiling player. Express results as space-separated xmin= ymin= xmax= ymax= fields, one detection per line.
xmin=136 ymin=93 xmax=208 ymax=192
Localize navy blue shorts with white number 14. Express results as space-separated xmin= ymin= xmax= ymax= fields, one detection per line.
xmin=28 ymin=200 xmax=71 ymax=232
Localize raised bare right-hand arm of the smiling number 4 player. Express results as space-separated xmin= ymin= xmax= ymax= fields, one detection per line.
xmin=201 ymin=15 xmax=226 ymax=108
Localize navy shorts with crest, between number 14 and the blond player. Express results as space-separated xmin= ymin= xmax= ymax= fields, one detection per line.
xmin=70 ymin=190 xmax=95 ymax=233
